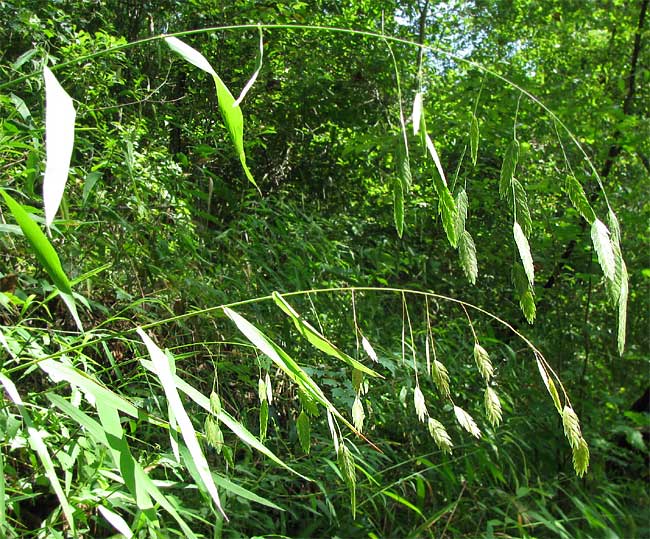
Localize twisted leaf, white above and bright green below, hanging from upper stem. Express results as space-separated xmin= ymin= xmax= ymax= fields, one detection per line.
xmin=165 ymin=37 xmax=259 ymax=191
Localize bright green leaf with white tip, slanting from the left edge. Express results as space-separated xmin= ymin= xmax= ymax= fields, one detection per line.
xmin=0 ymin=189 xmax=83 ymax=331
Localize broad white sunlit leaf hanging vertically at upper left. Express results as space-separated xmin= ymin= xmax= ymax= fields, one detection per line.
xmin=43 ymin=66 xmax=76 ymax=227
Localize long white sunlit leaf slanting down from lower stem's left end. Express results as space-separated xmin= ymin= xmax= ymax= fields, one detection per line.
xmin=136 ymin=328 xmax=227 ymax=518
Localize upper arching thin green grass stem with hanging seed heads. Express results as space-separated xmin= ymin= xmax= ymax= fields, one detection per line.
xmin=0 ymin=23 xmax=612 ymax=210
